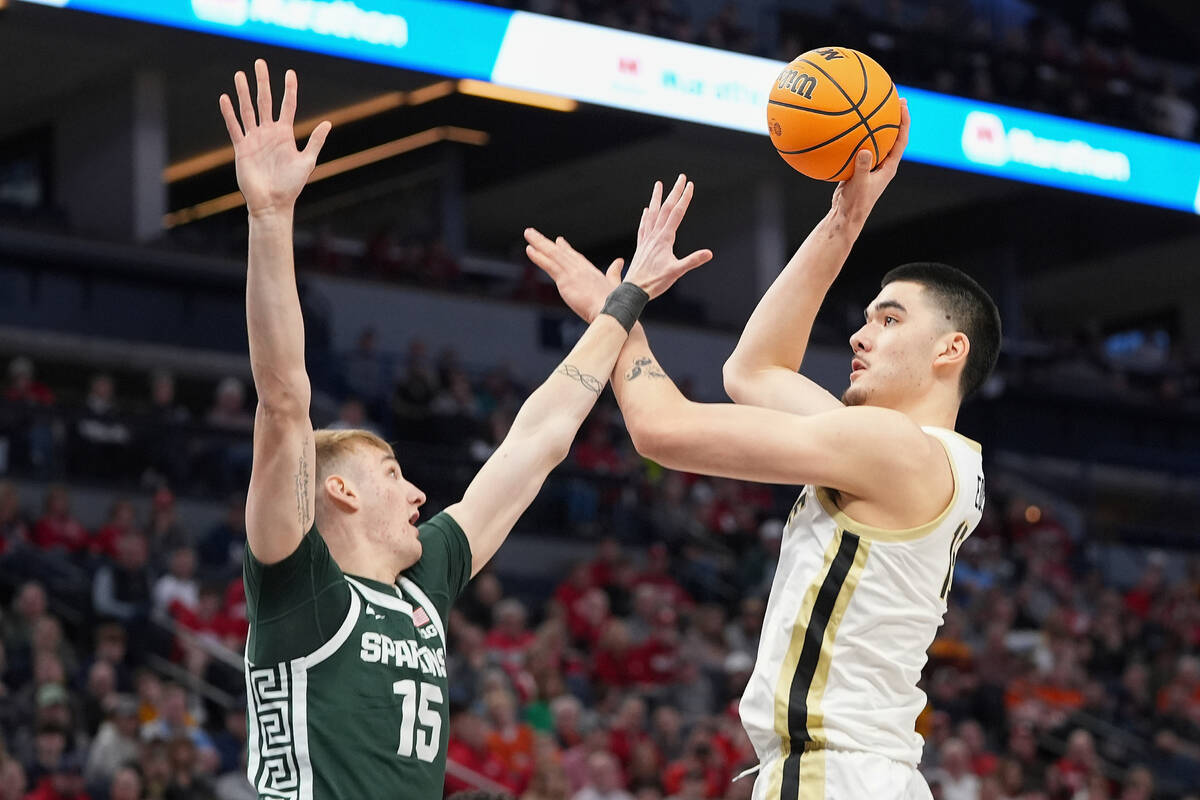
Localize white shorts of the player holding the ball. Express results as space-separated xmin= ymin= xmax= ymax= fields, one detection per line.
xmin=743 ymin=750 xmax=934 ymax=800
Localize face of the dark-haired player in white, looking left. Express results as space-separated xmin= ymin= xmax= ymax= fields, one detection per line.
xmin=841 ymin=281 xmax=946 ymax=409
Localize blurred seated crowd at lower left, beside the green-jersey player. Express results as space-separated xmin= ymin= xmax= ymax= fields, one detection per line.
xmin=0 ymin=481 xmax=257 ymax=800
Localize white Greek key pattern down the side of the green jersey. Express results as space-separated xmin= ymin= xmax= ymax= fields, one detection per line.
xmin=250 ymin=663 xmax=300 ymax=800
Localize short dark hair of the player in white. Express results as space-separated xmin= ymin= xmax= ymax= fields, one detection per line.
xmin=880 ymin=261 xmax=1001 ymax=397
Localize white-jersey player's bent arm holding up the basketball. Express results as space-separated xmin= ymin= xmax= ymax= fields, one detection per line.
xmin=724 ymin=100 xmax=908 ymax=414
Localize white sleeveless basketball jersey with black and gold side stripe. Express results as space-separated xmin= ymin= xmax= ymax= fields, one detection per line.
xmin=740 ymin=427 xmax=984 ymax=772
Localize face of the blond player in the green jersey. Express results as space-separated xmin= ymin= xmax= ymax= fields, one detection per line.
xmin=360 ymin=447 xmax=425 ymax=566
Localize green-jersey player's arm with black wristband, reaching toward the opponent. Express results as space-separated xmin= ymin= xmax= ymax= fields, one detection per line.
xmin=446 ymin=175 xmax=713 ymax=575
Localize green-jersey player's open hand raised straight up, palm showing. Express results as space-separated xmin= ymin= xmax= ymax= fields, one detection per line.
xmin=220 ymin=59 xmax=332 ymax=215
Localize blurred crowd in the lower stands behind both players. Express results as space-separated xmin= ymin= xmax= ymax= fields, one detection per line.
xmin=0 ymin=462 xmax=1200 ymax=800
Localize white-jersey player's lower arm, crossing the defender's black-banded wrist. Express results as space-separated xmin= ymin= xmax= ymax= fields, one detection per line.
xmin=530 ymin=171 xmax=954 ymax=528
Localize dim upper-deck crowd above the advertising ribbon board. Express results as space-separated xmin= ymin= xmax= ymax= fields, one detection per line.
xmin=480 ymin=0 xmax=1200 ymax=139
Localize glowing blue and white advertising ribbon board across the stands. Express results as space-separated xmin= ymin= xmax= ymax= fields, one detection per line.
xmin=16 ymin=0 xmax=1200 ymax=213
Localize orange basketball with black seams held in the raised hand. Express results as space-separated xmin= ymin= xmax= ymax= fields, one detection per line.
xmin=767 ymin=47 xmax=900 ymax=181
